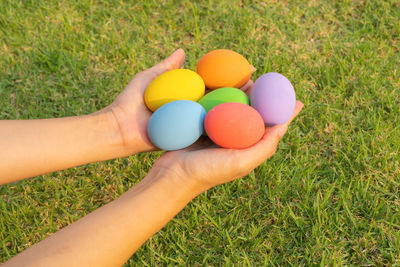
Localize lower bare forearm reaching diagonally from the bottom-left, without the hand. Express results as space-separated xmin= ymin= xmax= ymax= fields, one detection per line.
xmin=5 ymin=168 xmax=205 ymax=266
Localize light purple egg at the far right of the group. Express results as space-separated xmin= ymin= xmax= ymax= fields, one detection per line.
xmin=250 ymin=72 xmax=296 ymax=126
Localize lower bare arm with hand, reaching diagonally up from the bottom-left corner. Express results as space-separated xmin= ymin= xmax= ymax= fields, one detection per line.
xmin=5 ymin=102 xmax=302 ymax=266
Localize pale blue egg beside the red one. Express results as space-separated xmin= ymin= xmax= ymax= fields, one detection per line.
xmin=147 ymin=100 xmax=206 ymax=150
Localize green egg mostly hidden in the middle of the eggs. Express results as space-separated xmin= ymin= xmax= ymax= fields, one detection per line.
xmin=198 ymin=87 xmax=250 ymax=112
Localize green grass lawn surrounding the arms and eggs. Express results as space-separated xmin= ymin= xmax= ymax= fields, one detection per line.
xmin=0 ymin=0 xmax=400 ymax=266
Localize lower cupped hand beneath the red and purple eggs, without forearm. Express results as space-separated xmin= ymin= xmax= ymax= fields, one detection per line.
xmin=153 ymin=101 xmax=303 ymax=191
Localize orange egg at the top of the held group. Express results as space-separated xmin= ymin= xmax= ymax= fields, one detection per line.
xmin=196 ymin=49 xmax=253 ymax=89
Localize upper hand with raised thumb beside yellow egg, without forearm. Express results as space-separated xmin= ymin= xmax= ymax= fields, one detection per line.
xmin=100 ymin=49 xmax=185 ymax=156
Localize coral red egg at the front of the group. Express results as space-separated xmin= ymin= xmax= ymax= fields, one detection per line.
xmin=204 ymin=103 xmax=265 ymax=149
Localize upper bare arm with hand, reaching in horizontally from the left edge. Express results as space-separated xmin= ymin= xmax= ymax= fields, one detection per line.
xmin=0 ymin=49 xmax=185 ymax=184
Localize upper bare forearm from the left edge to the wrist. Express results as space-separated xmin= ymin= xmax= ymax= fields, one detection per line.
xmin=0 ymin=113 xmax=121 ymax=184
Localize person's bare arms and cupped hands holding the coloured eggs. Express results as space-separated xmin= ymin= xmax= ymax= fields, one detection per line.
xmin=0 ymin=49 xmax=303 ymax=266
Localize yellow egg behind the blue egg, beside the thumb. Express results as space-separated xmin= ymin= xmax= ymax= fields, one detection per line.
xmin=144 ymin=69 xmax=205 ymax=111
